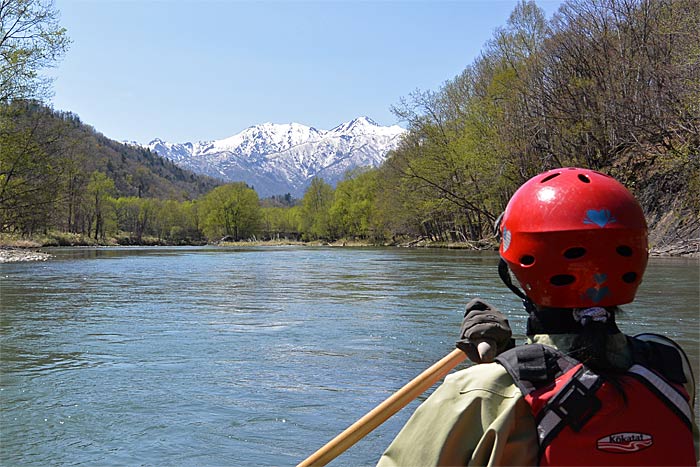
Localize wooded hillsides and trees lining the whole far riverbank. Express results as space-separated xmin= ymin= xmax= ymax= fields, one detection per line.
xmin=0 ymin=0 xmax=700 ymax=247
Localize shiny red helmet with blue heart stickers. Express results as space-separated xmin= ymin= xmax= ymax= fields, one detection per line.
xmin=500 ymin=168 xmax=648 ymax=308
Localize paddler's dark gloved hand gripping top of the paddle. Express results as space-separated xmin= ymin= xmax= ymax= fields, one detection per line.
xmin=456 ymin=298 xmax=515 ymax=363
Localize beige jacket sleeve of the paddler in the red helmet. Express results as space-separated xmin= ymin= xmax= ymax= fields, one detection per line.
xmin=378 ymin=363 xmax=537 ymax=467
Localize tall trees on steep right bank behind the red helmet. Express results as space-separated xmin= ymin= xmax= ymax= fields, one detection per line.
xmin=380 ymin=0 xmax=700 ymax=247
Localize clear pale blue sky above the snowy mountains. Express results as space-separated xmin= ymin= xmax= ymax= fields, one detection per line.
xmin=51 ymin=0 xmax=561 ymax=143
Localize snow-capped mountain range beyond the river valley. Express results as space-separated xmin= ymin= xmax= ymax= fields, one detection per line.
xmin=146 ymin=117 xmax=406 ymax=197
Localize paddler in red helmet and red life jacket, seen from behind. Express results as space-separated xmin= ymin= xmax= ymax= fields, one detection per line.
xmin=378 ymin=168 xmax=699 ymax=467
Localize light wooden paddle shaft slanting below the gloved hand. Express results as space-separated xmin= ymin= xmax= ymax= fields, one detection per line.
xmin=297 ymin=349 xmax=467 ymax=467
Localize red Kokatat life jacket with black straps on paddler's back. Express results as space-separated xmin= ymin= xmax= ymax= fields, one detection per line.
xmin=496 ymin=335 xmax=696 ymax=466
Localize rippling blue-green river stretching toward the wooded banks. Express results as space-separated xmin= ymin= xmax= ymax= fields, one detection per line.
xmin=0 ymin=247 xmax=700 ymax=466
